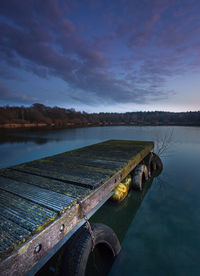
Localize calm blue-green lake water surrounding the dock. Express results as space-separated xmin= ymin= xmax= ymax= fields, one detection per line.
xmin=0 ymin=126 xmax=200 ymax=276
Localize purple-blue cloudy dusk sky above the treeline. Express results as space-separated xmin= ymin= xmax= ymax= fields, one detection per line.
xmin=0 ymin=0 xmax=200 ymax=112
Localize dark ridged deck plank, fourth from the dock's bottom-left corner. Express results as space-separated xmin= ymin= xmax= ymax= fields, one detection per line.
xmin=0 ymin=169 xmax=90 ymax=199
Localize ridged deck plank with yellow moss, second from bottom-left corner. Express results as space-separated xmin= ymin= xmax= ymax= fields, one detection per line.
xmin=0 ymin=191 xmax=58 ymax=234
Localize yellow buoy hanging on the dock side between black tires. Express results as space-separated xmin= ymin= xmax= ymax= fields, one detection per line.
xmin=112 ymin=175 xmax=131 ymax=201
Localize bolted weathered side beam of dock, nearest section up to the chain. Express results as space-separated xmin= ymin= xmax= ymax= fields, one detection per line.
xmin=0 ymin=205 xmax=81 ymax=276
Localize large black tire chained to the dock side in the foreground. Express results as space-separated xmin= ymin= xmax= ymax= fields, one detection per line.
xmin=61 ymin=223 xmax=121 ymax=276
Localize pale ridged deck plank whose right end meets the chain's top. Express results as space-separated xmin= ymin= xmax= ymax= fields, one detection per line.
xmin=0 ymin=177 xmax=75 ymax=212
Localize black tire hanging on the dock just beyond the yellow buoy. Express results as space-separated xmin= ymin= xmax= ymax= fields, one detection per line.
xmin=133 ymin=164 xmax=148 ymax=191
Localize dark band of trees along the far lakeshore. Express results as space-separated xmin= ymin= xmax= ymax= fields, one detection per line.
xmin=0 ymin=103 xmax=200 ymax=128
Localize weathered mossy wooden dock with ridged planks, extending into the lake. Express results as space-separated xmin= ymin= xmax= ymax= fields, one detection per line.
xmin=0 ymin=140 xmax=154 ymax=276
